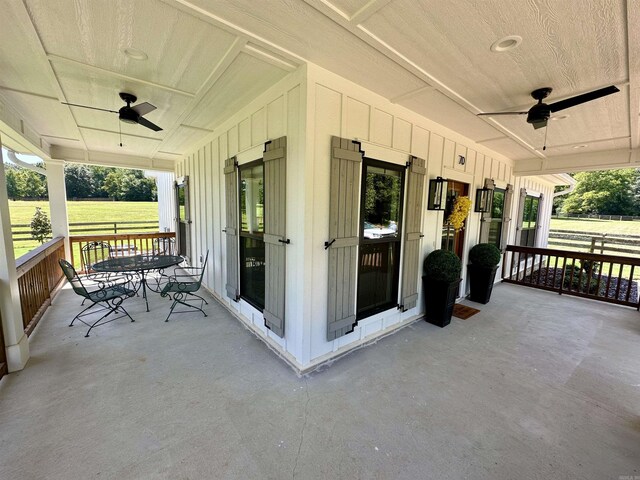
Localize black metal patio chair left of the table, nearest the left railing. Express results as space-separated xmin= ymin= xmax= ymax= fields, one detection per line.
xmin=59 ymin=258 xmax=136 ymax=337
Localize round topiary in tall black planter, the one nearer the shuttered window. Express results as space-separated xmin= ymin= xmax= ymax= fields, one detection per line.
xmin=422 ymin=250 xmax=462 ymax=327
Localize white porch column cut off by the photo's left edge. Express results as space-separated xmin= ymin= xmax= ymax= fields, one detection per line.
xmin=0 ymin=139 xmax=29 ymax=372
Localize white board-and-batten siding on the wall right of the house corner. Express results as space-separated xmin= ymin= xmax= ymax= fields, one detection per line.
xmin=302 ymin=66 xmax=553 ymax=370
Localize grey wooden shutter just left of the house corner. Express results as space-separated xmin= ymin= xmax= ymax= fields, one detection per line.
xmin=263 ymin=137 xmax=288 ymax=337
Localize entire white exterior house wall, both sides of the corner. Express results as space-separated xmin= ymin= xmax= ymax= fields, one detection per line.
xmin=176 ymin=65 xmax=553 ymax=369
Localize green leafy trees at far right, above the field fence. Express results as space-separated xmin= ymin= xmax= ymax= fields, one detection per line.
xmin=562 ymin=169 xmax=640 ymax=215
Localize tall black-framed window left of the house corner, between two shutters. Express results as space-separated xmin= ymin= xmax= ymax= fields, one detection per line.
xmin=239 ymin=160 xmax=265 ymax=310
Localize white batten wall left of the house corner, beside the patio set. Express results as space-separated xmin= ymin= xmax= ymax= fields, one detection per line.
xmin=176 ymin=67 xmax=308 ymax=368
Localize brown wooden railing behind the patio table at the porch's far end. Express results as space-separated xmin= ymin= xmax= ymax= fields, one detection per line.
xmin=69 ymin=232 xmax=176 ymax=272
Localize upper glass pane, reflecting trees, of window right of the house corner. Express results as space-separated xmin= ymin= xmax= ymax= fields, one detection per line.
xmin=363 ymin=166 xmax=402 ymax=239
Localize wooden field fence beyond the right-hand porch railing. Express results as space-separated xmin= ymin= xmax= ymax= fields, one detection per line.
xmin=548 ymin=229 xmax=640 ymax=255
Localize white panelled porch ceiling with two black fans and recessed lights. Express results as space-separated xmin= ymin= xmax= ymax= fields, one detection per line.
xmin=0 ymin=0 xmax=640 ymax=169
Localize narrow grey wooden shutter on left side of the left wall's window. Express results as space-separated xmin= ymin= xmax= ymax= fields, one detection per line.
xmin=224 ymin=157 xmax=240 ymax=302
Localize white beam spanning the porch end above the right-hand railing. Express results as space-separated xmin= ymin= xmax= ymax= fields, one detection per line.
xmin=513 ymin=148 xmax=640 ymax=177
